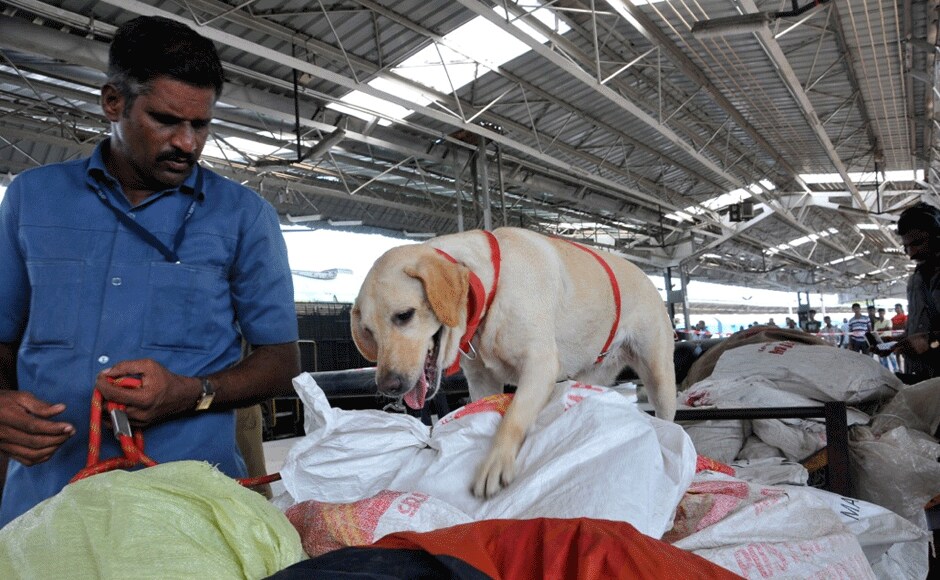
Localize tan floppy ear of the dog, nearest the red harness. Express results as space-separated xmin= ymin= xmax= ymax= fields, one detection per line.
xmin=405 ymin=252 xmax=470 ymax=328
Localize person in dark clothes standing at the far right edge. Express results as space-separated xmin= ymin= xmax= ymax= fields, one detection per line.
xmin=894 ymin=203 xmax=940 ymax=380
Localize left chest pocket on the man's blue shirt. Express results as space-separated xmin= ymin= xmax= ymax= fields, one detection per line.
xmin=25 ymin=260 xmax=84 ymax=348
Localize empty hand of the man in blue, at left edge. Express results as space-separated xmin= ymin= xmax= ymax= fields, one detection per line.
xmin=0 ymin=389 xmax=75 ymax=466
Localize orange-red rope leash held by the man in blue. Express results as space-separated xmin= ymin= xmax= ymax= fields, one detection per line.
xmin=69 ymin=377 xmax=281 ymax=487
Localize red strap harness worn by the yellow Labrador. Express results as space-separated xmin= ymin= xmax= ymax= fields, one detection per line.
xmin=435 ymin=230 xmax=621 ymax=376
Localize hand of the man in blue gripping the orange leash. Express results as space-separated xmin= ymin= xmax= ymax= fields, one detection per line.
xmin=95 ymin=359 xmax=202 ymax=427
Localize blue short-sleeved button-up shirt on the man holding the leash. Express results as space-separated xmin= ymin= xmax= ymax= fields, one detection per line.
xmin=0 ymin=140 xmax=297 ymax=526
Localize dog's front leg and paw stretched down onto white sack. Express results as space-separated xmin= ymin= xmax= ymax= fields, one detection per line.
xmin=473 ymin=357 xmax=557 ymax=497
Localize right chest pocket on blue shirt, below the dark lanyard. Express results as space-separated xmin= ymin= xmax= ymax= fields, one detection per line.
xmin=142 ymin=262 xmax=226 ymax=352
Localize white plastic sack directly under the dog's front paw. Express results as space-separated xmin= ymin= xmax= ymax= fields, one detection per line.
xmin=281 ymin=374 xmax=696 ymax=538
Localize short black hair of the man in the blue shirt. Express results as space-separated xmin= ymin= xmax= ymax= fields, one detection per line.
xmin=108 ymin=16 xmax=225 ymax=99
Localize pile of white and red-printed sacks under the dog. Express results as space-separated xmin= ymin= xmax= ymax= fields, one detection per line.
xmin=274 ymin=376 xmax=925 ymax=578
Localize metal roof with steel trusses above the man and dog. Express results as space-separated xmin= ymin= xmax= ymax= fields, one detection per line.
xmin=0 ymin=0 xmax=940 ymax=297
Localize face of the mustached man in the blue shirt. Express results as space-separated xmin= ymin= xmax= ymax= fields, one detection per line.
xmin=102 ymin=77 xmax=215 ymax=192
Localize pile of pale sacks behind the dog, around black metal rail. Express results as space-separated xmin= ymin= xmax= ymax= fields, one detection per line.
xmin=679 ymin=341 xmax=940 ymax=578
